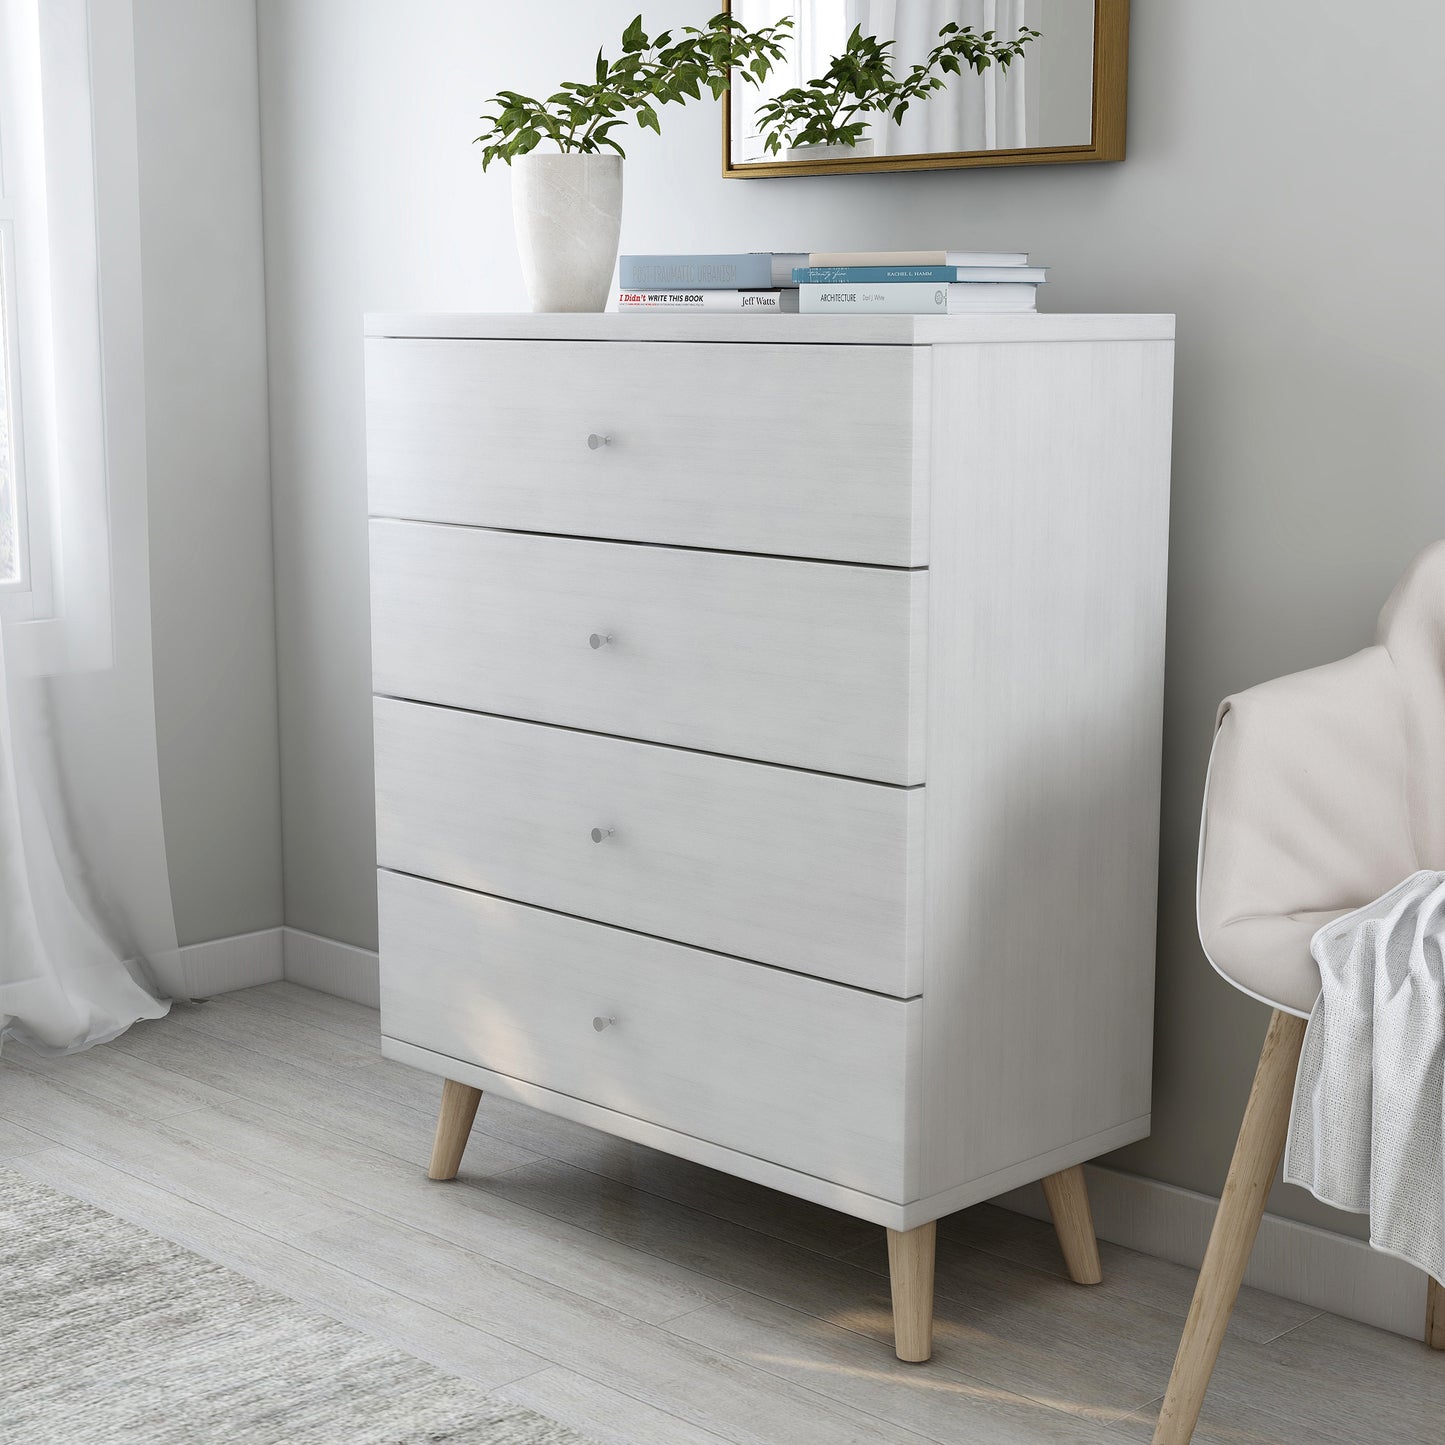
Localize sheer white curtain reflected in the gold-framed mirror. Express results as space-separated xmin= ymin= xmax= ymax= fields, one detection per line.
xmin=844 ymin=0 xmax=1036 ymax=156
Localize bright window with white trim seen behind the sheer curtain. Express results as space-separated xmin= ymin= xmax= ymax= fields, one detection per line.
xmin=0 ymin=0 xmax=128 ymax=664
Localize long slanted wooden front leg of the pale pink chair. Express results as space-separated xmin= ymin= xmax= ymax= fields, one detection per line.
xmin=1155 ymin=1013 xmax=1305 ymax=1445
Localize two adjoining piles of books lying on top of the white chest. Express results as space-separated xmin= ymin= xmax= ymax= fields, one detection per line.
xmin=617 ymin=251 xmax=1048 ymax=315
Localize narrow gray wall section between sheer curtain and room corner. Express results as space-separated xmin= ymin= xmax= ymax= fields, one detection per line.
xmin=134 ymin=0 xmax=282 ymax=944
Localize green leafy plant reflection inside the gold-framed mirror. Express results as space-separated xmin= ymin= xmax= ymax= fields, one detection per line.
xmin=757 ymin=20 xmax=1042 ymax=155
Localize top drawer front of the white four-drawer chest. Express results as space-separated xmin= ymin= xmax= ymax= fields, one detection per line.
xmin=366 ymin=337 xmax=929 ymax=566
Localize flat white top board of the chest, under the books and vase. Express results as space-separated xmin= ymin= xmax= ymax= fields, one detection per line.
xmin=366 ymin=311 xmax=1175 ymax=347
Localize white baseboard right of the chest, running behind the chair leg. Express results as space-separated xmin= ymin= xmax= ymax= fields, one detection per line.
xmin=994 ymin=1165 xmax=1425 ymax=1340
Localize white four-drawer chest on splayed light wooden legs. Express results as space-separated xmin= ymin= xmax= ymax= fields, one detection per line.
xmin=366 ymin=315 xmax=1173 ymax=1360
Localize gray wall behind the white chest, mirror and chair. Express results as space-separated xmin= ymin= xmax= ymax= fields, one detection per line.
xmin=259 ymin=0 xmax=1445 ymax=1227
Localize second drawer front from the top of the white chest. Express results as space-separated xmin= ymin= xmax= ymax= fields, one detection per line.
xmin=371 ymin=522 xmax=928 ymax=783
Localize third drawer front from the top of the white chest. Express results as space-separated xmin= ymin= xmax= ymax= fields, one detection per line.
xmin=374 ymin=698 xmax=923 ymax=997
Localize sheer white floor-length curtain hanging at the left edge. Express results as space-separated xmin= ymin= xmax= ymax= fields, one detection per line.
xmin=0 ymin=0 xmax=184 ymax=1052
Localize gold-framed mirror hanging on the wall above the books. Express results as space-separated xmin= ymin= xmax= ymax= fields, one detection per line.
xmin=723 ymin=0 xmax=1129 ymax=179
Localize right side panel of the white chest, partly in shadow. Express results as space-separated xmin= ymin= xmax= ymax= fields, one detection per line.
xmin=923 ymin=341 xmax=1172 ymax=1202
